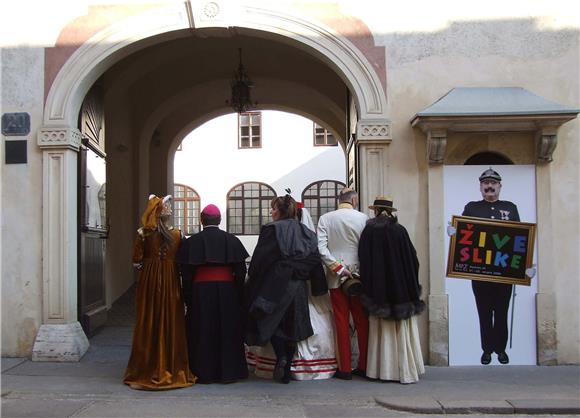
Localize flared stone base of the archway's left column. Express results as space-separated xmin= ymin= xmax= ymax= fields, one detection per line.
xmin=32 ymin=322 xmax=89 ymax=362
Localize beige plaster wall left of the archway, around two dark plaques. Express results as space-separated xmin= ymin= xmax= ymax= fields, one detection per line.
xmin=0 ymin=46 xmax=44 ymax=356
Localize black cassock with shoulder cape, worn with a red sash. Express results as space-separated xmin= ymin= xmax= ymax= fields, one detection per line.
xmin=177 ymin=227 xmax=249 ymax=383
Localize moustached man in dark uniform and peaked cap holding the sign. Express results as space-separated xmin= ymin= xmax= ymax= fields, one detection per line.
xmin=462 ymin=168 xmax=520 ymax=364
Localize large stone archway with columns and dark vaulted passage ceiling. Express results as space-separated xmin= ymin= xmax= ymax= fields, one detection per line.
xmin=33 ymin=2 xmax=391 ymax=360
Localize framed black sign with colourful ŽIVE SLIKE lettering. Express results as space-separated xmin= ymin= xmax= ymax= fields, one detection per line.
xmin=447 ymin=216 xmax=536 ymax=286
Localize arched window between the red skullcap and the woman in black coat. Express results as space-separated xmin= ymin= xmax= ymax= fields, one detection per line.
xmin=227 ymin=182 xmax=276 ymax=235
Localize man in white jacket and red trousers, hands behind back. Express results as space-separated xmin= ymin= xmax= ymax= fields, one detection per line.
xmin=317 ymin=188 xmax=369 ymax=380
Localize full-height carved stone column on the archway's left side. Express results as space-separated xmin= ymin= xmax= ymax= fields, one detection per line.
xmin=32 ymin=126 xmax=89 ymax=361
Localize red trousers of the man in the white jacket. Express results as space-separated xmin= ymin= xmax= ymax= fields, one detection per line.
xmin=330 ymin=288 xmax=369 ymax=372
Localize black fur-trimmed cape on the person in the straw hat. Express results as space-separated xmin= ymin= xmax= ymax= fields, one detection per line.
xmin=358 ymin=216 xmax=425 ymax=320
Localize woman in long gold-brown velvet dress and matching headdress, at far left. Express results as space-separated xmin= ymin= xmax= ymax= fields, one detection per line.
xmin=123 ymin=195 xmax=196 ymax=390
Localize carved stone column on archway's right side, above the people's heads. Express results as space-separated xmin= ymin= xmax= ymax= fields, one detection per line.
xmin=356 ymin=119 xmax=392 ymax=212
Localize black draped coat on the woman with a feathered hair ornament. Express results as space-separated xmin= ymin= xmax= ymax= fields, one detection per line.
xmin=244 ymin=219 xmax=328 ymax=345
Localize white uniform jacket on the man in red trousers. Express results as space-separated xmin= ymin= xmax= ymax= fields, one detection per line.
xmin=317 ymin=203 xmax=369 ymax=289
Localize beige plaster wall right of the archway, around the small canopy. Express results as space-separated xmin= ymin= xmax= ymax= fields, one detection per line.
xmin=365 ymin=8 xmax=580 ymax=364
